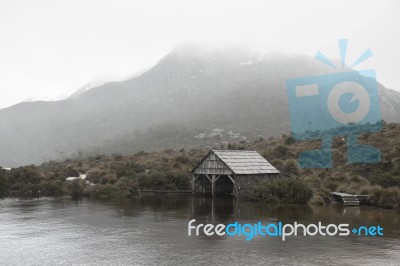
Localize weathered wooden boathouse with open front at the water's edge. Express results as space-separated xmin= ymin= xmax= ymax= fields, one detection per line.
xmin=192 ymin=150 xmax=280 ymax=197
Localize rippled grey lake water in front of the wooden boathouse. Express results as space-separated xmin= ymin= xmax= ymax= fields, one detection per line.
xmin=0 ymin=195 xmax=400 ymax=265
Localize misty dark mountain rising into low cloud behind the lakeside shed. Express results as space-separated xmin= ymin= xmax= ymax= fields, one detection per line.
xmin=0 ymin=45 xmax=400 ymax=167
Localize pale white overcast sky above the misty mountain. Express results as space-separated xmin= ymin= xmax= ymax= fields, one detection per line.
xmin=0 ymin=0 xmax=400 ymax=108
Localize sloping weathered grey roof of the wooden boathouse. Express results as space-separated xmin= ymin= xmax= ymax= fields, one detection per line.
xmin=212 ymin=150 xmax=279 ymax=175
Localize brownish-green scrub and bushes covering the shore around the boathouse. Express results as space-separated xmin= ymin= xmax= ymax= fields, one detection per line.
xmin=0 ymin=123 xmax=400 ymax=208
